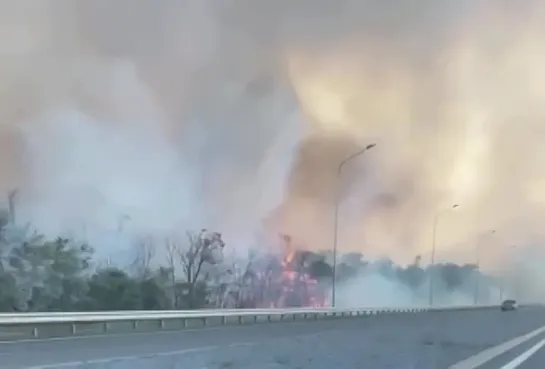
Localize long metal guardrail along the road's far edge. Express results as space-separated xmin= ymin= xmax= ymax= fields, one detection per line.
xmin=0 ymin=305 xmax=498 ymax=340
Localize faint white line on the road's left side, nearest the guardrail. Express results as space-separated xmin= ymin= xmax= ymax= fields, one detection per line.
xmin=22 ymin=342 xmax=255 ymax=369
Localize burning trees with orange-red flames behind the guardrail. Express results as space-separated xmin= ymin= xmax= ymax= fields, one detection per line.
xmin=215 ymin=235 xmax=331 ymax=308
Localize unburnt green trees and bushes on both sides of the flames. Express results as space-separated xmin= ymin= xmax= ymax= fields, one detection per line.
xmin=0 ymin=213 xmax=496 ymax=312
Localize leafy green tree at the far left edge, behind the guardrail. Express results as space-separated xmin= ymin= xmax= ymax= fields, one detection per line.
xmin=0 ymin=220 xmax=92 ymax=311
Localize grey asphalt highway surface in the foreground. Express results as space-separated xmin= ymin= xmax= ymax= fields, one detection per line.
xmin=0 ymin=308 xmax=545 ymax=369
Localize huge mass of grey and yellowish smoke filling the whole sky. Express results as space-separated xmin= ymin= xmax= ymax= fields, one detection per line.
xmin=0 ymin=0 xmax=545 ymax=300
